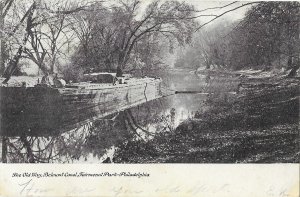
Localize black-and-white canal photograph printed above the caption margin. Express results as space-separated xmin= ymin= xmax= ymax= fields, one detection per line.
xmin=0 ymin=0 xmax=300 ymax=164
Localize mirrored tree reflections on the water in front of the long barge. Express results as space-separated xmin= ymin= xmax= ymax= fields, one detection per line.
xmin=2 ymin=95 xmax=185 ymax=163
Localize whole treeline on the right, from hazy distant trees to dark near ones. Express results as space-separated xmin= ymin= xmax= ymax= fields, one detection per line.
xmin=175 ymin=1 xmax=300 ymax=75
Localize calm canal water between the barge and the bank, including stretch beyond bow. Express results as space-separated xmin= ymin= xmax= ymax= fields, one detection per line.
xmin=1 ymin=70 xmax=237 ymax=163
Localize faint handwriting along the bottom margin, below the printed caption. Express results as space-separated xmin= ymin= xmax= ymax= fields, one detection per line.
xmin=18 ymin=179 xmax=290 ymax=197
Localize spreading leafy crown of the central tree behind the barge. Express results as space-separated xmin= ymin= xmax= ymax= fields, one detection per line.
xmin=70 ymin=0 xmax=196 ymax=74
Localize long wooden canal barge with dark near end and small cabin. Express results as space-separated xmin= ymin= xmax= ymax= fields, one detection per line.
xmin=0 ymin=73 xmax=162 ymax=136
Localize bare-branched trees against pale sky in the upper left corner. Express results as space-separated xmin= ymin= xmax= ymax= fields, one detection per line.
xmin=1 ymin=0 xmax=88 ymax=83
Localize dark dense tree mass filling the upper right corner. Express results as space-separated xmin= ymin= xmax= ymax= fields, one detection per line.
xmin=229 ymin=2 xmax=300 ymax=72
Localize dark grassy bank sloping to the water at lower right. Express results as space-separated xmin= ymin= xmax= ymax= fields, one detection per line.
xmin=114 ymin=76 xmax=300 ymax=163
